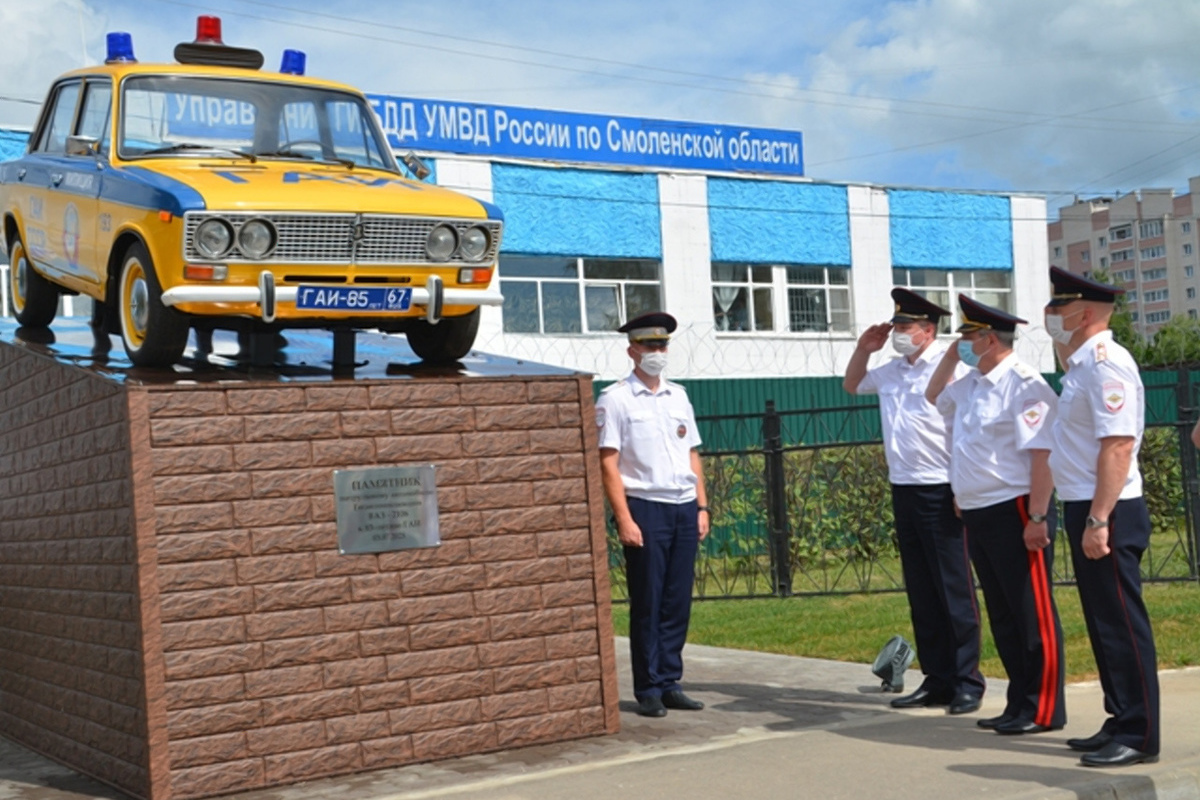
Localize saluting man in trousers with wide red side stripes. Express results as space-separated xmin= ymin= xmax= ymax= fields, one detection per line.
xmin=925 ymin=295 xmax=1067 ymax=734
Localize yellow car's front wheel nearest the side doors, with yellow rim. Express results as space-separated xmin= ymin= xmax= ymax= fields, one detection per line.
xmin=118 ymin=243 xmax=188 ymax=367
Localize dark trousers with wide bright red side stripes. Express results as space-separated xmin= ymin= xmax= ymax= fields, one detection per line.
xmin=962 ymin=495 xmax=1067 ymax=728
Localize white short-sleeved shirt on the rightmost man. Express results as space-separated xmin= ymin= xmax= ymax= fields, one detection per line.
xmin=1050 ymin=331 xmax=1146 ymax=501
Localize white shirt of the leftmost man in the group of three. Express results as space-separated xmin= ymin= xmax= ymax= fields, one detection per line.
xmin=857 ymin=341 xmax=967 ymax=486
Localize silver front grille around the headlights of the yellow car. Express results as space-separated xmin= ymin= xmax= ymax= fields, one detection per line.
xmin=184 ymin=212 xmax=503 ymax=266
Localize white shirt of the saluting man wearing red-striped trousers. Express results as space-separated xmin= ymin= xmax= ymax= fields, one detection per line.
xmin=937 ymin=354 xmax=1058 ymax=511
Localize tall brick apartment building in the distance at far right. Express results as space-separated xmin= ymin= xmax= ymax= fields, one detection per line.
xmin=1048 ymin=176 xmax=1200 ymax=337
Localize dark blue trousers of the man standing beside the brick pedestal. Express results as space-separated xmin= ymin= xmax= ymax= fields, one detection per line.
xmin=625 ymin=498 xmax=700 ymax=700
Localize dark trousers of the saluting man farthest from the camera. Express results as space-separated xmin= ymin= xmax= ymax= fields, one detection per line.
xmin=892 ymin=483 xmax=985 ymax=702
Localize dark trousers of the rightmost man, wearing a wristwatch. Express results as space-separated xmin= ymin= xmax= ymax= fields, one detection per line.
xmin=1063 ymin=498 xmax=1159 ymax=754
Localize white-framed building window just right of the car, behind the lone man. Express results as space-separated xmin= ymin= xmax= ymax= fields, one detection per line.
xmin=499 ymin=255 xmax=662 ymax=333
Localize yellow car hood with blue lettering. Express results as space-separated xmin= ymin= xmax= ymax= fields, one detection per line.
xmin=131 ymin=160 xmax=488 ymax=218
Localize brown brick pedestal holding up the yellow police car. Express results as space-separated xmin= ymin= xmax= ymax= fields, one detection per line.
xmin=0 ymin=324 xmax=618 ymax=800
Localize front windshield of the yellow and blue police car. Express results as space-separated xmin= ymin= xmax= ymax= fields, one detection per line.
xmin=120 ymin=76 xmax=398 ymax=173
